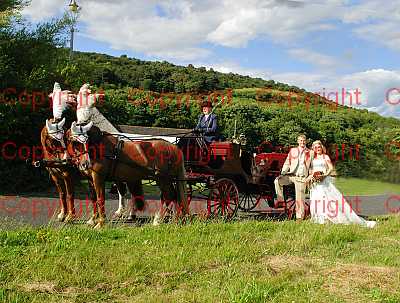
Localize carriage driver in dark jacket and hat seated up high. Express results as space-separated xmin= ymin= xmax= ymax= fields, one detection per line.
xmin=194 ymin=101 xmax=217 ymax=143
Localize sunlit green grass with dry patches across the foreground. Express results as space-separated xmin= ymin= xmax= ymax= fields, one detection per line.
xmin=0 ymin=216 xmax=400 ymax=302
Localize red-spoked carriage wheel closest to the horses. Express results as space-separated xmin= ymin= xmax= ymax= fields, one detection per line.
xmin=207 ymin=178 xmax=239 ymax=220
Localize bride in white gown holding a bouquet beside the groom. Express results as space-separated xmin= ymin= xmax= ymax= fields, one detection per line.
xmin=306 ymin=140 xmax=376 ymax=228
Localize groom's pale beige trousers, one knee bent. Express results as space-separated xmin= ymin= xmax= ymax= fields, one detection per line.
xmin=274 ymin=175 xmax=306 ymax=219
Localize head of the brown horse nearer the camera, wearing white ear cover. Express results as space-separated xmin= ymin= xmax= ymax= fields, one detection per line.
xmin=67 ymin=121 xmax=93 ymax=171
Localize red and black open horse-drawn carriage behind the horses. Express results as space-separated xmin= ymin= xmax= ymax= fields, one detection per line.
xmin=177 ymin=133 xmax=295 ymax=219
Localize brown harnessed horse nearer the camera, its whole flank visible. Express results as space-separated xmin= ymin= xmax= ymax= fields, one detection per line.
xmin=67 ymin=122 xmax=189 ymax=227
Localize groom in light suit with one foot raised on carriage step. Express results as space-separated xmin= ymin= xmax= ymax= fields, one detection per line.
xmin=274 ymin=135 xmax=312 ymax=220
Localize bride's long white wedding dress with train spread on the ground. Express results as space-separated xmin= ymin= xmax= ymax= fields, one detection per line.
xmin=310 ymin=158 xmax=376 ymax=228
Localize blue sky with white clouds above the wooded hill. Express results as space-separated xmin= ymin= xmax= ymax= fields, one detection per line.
xmin=24 ymin=0 xmax=400 ymax=118
